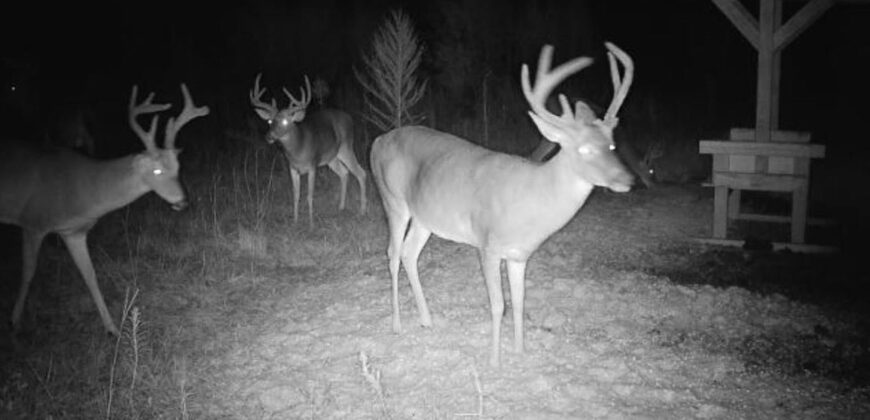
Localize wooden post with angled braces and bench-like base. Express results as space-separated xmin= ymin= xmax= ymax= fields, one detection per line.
xmin=699 ymin=0 xmax=860 ymax=249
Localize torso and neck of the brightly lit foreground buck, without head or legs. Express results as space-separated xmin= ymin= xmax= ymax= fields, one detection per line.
xmin=371 ymin=126 xmax=594 ymax=258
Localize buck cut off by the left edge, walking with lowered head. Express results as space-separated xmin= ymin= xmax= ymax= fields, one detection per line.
xmin=0 ymin=84 xmax=209 ymax=334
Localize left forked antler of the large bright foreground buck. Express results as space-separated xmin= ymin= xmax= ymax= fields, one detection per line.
xmin=521 ymin=45 xmax=592 ymax=123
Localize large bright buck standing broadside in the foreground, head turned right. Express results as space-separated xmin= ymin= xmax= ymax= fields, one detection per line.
xmin=371 ymin=43 xmax=633 ymax=366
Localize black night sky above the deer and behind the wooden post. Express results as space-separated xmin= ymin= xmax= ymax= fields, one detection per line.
xmin=0 ymin=0 xmax=870 ymax=152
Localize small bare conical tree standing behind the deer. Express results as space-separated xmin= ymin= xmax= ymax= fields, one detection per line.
xmin=354 ymin=10 xmax=427 ymax=132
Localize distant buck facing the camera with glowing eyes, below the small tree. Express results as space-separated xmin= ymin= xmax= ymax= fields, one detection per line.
xmin=248 ymin=74 xmax=367 ymax=225
